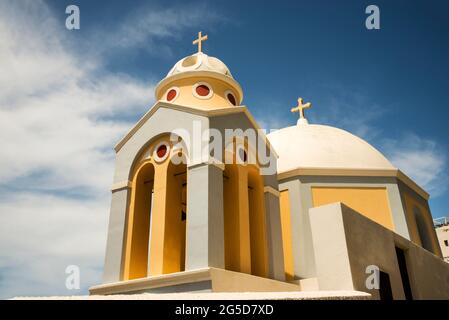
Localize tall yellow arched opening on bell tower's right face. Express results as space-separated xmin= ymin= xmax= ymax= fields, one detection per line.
xmin=223 ymin=146 xmax=268 ymax=277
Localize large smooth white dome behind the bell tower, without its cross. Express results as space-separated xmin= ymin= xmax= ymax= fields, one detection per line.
xmin=267 ymin=124 xmax=395 ymax=173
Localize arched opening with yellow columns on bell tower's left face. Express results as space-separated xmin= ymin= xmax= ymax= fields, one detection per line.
xmin=123 ymin=139 xmax=188 ymax=280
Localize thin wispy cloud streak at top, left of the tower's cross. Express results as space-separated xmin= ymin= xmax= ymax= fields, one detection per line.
xmin=83 ymin=2 xmax=224 ymax=60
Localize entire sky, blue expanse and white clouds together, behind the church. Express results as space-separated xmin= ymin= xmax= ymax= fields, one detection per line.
xmin=0 ymin=0 xmax=449 ymax=297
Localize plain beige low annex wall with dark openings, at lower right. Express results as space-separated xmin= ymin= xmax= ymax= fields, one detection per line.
xmin=310 ymin=203 xmax=449 ymax=299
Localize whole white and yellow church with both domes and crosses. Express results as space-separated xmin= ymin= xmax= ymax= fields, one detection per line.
xmin=90 ymin=33 xmax=449 ymax=299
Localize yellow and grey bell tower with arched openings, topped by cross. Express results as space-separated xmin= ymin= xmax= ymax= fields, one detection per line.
xmin=91 ymin=32 xmax=297 ymax=294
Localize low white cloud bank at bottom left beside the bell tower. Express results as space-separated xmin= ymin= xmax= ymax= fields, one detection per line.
xmin=0 ymin=192 xmax=108 ymax=297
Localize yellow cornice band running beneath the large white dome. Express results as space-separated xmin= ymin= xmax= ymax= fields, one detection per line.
xmin=277 ymin=168 xmax=430 ymax=200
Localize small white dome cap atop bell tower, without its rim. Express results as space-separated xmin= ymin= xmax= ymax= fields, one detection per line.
xmin=167 ymin=52 xmax=232 ymax=78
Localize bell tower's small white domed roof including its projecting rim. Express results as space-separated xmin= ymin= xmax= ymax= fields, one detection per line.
xmin=156 ymin=52 xmax=243 ymax=102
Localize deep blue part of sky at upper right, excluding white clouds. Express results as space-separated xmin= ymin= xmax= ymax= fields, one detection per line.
xmin=49 ymin=0 xmax=449 ymax=216
